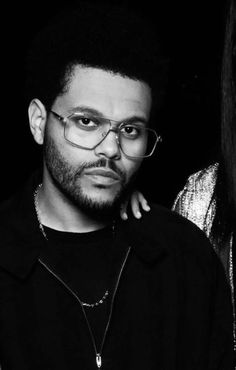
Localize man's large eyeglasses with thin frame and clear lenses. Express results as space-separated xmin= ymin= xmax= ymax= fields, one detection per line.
xmin=50 ymin=110 xmax=162 ymax=158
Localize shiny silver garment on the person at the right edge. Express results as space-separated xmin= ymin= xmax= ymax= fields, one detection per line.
xmin=173 ymin=163 xmax=236 ymax=350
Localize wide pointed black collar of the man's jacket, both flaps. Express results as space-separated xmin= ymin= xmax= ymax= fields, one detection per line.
xmin=0 ymin=173 xmax=168 ymax=278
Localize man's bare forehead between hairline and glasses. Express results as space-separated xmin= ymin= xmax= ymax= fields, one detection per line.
xmin=56 ymin=66 xmax=151 ymax=120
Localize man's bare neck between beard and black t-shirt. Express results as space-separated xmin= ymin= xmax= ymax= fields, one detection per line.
xmin=37 ymin=183 xmax=109 ymax=233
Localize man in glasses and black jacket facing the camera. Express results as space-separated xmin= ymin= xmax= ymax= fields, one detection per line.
xmin=0 ymin=1 xmax=232 ymax=370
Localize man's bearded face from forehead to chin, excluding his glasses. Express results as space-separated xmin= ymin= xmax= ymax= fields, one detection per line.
xmin=44 ymin=66 xmax=151 ymax=212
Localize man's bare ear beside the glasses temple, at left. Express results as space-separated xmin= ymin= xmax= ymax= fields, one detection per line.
xmin=28 ymin=99 xmax=47 ymax=145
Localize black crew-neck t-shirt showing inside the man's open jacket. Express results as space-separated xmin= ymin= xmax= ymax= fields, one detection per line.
xmin=44 ymin=226 xmax=114 ymax=347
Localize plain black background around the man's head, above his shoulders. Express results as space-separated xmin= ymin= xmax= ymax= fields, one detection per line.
xmin=0 ymin=0 xmax=226 ymax=207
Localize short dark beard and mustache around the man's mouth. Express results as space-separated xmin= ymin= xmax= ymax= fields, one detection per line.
xmin=44 ymin=132 xmax=135 ymax=220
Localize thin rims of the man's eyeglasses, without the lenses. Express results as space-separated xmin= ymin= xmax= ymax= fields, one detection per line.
xmin=49 ymin=110 xmax=162 ymax=159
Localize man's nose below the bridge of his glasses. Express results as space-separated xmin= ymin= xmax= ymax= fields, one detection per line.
xmin=94 ymin=130 xmax=121 ymax=160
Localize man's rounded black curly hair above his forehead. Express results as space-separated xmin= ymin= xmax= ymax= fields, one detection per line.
xmin=26 ymin=2 xmax=168 ymax=115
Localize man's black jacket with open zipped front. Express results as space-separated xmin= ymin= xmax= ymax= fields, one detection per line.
xmin=0 ymin=174 xmax=233 ymax=370
